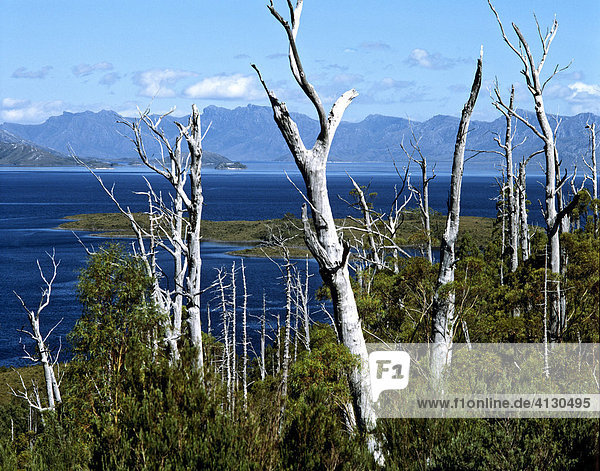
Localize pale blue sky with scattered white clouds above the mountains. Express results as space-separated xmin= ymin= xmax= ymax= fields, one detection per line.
xmin=0 ymin=0 xmax=600 ymax=123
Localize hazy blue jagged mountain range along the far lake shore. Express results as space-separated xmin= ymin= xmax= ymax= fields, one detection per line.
xmin=0 ymin=105 xmax=600 ymax=172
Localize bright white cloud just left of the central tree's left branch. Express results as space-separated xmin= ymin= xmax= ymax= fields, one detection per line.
xmin=184 ymin=74 xmax=263 ymax=100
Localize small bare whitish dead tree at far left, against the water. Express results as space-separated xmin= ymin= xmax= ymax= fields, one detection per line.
xmin=11 ymin=252 xmax=62 ymax=412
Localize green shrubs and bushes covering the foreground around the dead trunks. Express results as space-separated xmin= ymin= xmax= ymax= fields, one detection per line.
xmin=0 ymin=216 xmax=600 ymax=470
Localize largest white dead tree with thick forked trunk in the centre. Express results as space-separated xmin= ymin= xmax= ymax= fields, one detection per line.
xmin=253 ymin=0 xmax=381 ymax=461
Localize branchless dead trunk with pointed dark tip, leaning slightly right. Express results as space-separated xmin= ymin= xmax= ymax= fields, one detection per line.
xmin=431 ymin=47 xmax=483 ymax=387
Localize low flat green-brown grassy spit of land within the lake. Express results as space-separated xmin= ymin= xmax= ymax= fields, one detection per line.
xmin=59 ymin=212 xmax=494 ymax=257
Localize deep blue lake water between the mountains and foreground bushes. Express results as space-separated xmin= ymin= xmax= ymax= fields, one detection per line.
xmin=0 ymin=163 xmax=543 ymax=366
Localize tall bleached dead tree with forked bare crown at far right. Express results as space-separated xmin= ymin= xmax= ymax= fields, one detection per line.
xmin=488 ymin=0 xmax=576 ymax=342
